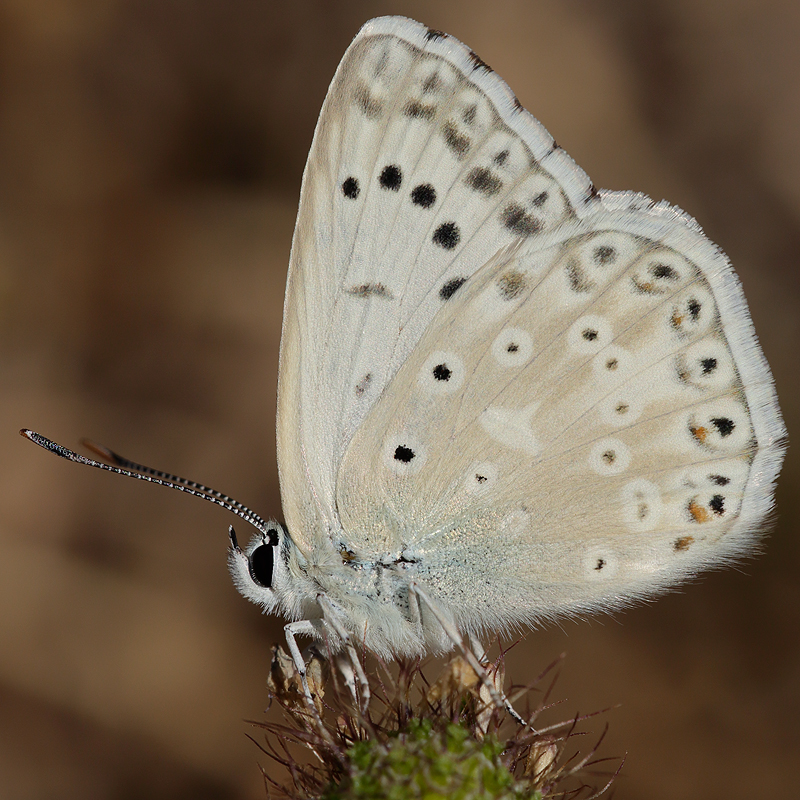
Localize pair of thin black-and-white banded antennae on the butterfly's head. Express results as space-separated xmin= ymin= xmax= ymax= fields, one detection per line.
xmin=20 ymin=428 xmax=268 ymax=533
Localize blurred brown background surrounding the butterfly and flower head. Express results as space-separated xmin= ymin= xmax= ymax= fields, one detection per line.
xmin=0 ymin=0 xmax=800 ymax=800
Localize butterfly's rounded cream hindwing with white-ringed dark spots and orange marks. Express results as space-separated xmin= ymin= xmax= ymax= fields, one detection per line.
xmin=337 ymin=210 xmax=780 ymax=630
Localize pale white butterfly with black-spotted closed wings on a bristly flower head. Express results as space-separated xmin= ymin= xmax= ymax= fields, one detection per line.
xmin=21 ymin=17 xmax=784 ymax=704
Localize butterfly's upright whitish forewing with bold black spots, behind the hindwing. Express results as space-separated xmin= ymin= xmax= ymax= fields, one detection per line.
xmin=279 ymin=19 xmax=593 ymax=552
